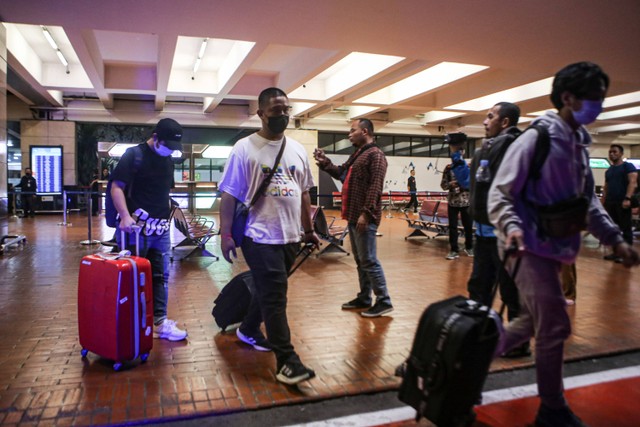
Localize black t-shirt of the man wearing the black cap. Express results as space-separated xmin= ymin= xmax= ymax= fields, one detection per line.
xmin=109 ymin=143 xmax=174 ymax=224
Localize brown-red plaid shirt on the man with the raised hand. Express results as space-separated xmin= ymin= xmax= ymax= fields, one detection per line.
xmin=321 ymin=143 xmax=387 ymax=225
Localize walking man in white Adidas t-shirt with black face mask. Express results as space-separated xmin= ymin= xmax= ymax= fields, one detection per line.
xmin=220 ymin=88 xmax=319 ymax=384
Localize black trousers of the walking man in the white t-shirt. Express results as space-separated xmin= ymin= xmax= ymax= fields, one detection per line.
xmin=242 ymin=237 xmax=300 ymax=369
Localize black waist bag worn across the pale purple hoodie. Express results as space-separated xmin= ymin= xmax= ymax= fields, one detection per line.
xmin=538 ymin=195 xmax=589 ymax=238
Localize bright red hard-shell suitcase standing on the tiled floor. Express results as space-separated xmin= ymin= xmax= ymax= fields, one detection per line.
xmin=78 ymin=227 xmax=153 ymax=371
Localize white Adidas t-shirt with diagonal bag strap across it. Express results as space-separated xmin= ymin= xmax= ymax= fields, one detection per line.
xmin=219 ymin=133 xmax=314 ymax=245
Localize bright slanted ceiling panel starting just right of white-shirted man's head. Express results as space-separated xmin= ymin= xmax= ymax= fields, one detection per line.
xmin=289 ymin=52 xmax=404 ymax=101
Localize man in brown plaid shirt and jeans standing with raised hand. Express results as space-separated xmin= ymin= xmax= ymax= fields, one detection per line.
xmin=314 ymin=119 xmax=393 ymax=317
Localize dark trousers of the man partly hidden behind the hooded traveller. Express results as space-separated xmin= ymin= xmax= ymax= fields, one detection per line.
xmin=467 ymin=234 xmax=520 ymax=321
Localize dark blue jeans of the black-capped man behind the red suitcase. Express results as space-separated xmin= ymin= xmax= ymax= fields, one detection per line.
xmin=116 ymin=228 xmax=171 ymax=325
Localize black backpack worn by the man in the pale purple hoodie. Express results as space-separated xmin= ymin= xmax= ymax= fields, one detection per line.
xmin=470 ymin=124 xmax=551 ymax=224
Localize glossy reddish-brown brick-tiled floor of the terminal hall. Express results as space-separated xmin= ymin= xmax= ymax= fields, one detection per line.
xmin=0 ymin=212 xmax=640 ymax=426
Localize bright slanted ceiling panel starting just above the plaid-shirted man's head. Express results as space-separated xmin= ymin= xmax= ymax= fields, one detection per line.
xmin=355 ymin=62 xmax=489 ymax=105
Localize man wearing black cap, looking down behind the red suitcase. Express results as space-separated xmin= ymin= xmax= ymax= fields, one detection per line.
xmin=111 ymin=119 xmax=187 ymax=341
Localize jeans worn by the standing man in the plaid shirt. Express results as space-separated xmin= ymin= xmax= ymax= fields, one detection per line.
xmin=349 ymin=223 xmax=391 ymax=305
